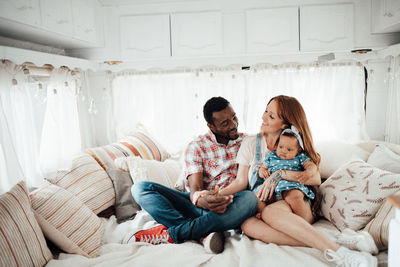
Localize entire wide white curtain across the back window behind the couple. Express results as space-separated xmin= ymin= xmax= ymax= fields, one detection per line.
xmin=112 ymin=63 xmax=367 ymax=152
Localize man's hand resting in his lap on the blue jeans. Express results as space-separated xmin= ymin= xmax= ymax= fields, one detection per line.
xmin=196 ymin=186 xmax=233 ymax=213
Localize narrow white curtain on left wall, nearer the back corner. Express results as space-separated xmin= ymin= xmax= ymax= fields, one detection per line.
xmin=40 ymin=67 xmax=81 ymax=175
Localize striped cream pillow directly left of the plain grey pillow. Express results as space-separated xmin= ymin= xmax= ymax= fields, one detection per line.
xmin=47 ymin=154 xmax=115 ymax=214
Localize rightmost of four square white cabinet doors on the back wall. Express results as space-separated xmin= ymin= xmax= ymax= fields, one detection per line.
xmin=300 ymin=4 xmax=354 ymax=51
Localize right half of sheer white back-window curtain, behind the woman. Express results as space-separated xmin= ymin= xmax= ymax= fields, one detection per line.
xmin=246 ymin=63 xmax=368 ymax=142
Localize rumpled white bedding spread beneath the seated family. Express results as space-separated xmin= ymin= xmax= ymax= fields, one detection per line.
xmin=46 ymin=211 xmax=387 ymax=267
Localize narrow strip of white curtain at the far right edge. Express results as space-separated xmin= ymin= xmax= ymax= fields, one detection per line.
xmin=385 ymin=56 xmax=400 ymax=144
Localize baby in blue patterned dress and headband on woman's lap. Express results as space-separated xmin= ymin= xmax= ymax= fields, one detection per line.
xmin=258 ymin=126 xmax=315 ymax=221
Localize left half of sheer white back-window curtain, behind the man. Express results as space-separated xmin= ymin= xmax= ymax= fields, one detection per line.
xmin=112 ymin=68 xmax=245 ymax=153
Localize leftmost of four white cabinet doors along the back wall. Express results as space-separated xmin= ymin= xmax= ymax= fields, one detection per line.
xmin=120 ymin=14 xmax=171 ymax=59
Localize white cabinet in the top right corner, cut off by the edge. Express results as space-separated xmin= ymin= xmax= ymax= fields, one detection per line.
xmin=371 ymin=0 xmax=400 ymax=33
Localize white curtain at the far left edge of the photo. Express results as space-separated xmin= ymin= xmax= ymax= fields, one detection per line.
xmin=0 ymin=61 xmax=44 ymax=191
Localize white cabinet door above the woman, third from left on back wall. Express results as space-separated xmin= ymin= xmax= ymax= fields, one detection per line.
xmin=246 ymin=7 xmax=299 ymax=53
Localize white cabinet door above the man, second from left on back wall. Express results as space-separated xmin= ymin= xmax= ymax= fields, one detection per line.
xmin=171 ymin=12 xmax=222 ymax=56
